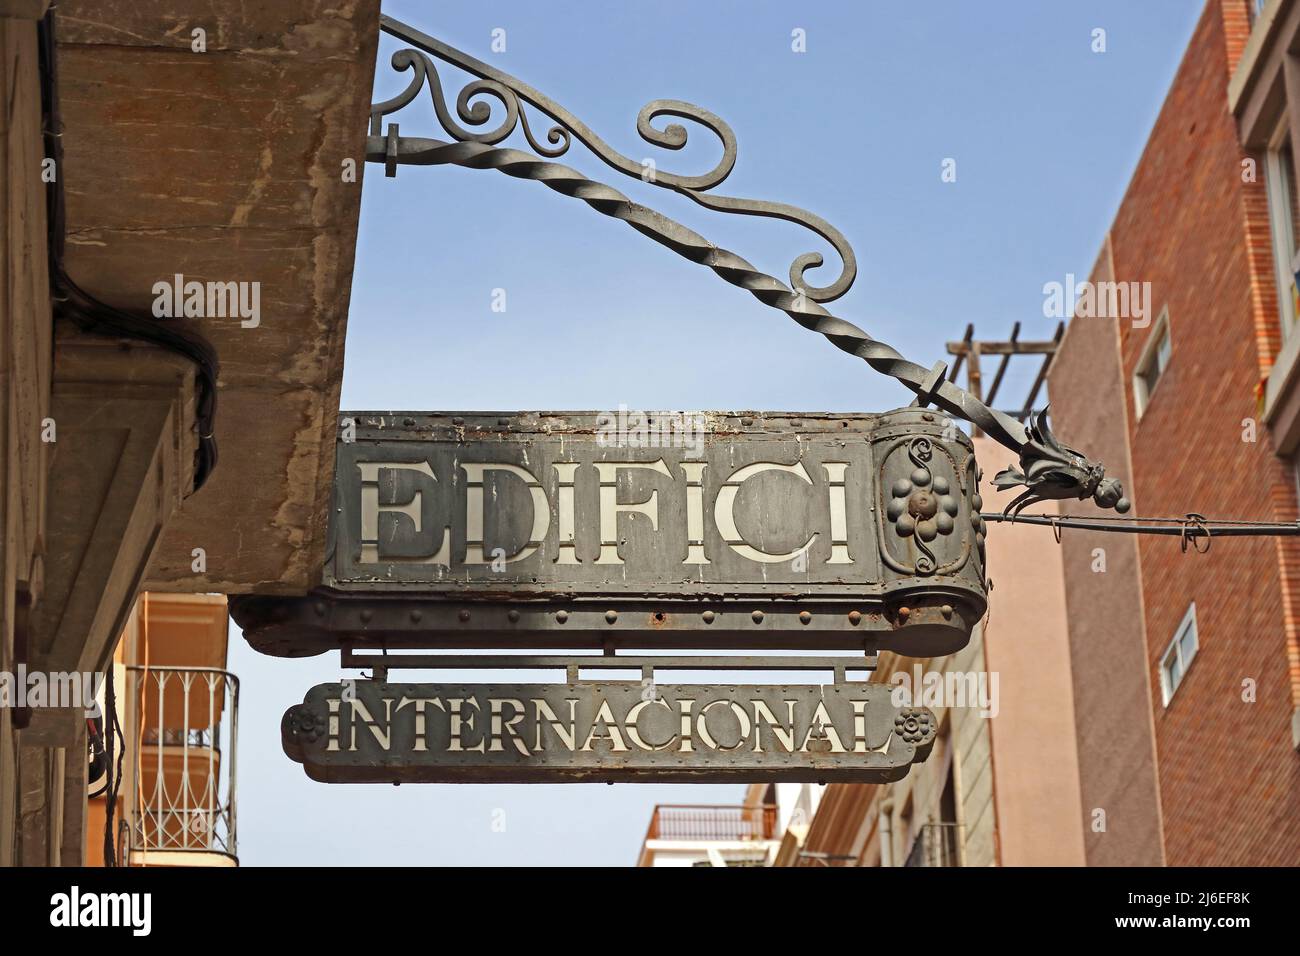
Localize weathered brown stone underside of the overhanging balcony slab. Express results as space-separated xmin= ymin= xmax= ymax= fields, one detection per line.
xmin=57 ymin=0 xmax=380 ymax=593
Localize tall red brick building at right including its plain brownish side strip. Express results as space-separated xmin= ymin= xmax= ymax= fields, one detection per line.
xmin=1049 ymin=0 xmax=1300 ymax=865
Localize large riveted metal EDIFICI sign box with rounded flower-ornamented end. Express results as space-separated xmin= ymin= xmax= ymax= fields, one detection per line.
xmin=231 ymin=408 xmax=985 ymax=656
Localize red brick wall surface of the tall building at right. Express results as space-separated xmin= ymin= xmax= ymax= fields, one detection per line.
xmin=1102 ymin=0 xmax=1300 ymax=865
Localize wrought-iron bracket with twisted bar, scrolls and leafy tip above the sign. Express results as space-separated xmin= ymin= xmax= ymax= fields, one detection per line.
xmin=365 ymin=16 xmax=1130 ymax=512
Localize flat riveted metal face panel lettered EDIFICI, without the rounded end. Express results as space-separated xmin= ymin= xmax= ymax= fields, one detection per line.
xmin=332 ymin=410 xmax=883 ymax=594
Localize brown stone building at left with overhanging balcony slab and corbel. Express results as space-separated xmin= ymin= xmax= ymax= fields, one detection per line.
xmin=0 ymin=0 xmax=380 ymax=866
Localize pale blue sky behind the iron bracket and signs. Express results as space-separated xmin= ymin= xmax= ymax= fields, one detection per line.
xmin=230 ymin=0 xmax=1201 ymax=865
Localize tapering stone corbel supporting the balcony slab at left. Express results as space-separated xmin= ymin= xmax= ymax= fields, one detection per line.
xmin=29 ymin=334 xmax=198 ymax=672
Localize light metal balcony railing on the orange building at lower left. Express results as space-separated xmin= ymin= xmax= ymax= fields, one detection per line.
xmin=125 ymin=666 xmax=239 ymax=862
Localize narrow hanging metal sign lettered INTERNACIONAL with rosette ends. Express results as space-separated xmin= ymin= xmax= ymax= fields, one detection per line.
xmin=281 ymin=680 xmax=937 ymax=783
